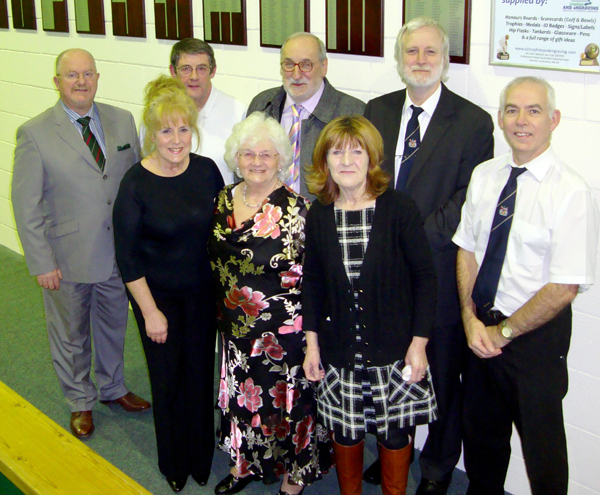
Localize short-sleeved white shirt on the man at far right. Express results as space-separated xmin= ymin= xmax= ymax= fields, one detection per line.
xmin=452 ymin=147 xmax=599 ymax=316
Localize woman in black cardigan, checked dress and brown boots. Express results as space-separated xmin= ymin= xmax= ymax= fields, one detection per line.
xmin=302 ymin=116 xmax=437 ymax=494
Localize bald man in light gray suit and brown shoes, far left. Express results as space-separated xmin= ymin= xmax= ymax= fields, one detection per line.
xmin=12 ymin=49 xmax=150 ymax=438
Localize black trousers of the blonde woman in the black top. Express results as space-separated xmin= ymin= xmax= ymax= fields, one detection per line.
xmin=128 ymin=292 xmax=216 ymax=479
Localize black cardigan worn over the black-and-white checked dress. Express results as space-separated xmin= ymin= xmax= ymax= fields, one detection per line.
xmin=302 ymin=189 xmax=437 ymax=369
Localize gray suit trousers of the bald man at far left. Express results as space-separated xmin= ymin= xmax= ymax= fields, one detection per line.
xmin=42 ymin=267 xmax=129 ymax=412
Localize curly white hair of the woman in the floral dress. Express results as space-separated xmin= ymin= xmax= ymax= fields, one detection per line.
xmin=224 ymin=112 xmax=293 ymax=181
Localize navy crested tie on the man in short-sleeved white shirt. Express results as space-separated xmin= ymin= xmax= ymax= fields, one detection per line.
xmin=472 ymin=167 xmax=527 ymax=311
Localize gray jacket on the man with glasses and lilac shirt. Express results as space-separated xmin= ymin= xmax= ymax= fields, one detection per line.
xmin=247 ymin=78 xmax=365 ymax=200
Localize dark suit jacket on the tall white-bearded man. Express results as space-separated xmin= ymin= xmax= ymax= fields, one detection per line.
xmin=365 ymin=84 xmax=494 ymax=326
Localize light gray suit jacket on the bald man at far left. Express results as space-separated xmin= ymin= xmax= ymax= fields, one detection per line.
xmin=12 ymin=100 xmax=140 ymax=283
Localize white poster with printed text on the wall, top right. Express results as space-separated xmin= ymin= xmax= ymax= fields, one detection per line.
xmin=490 ymin=0 xmax=600 ymax=74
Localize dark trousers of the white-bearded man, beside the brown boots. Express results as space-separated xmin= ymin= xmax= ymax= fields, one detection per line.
xmin=419 ymin=321 xmax=469 ymax=481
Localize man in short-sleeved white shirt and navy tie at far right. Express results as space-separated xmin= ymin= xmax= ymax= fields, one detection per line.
xmin=453 ymin=77 xmax=599 ymax=495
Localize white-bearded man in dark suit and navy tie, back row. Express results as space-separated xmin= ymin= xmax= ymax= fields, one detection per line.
xmin=364 ymin=17 xmax=494 ymax=495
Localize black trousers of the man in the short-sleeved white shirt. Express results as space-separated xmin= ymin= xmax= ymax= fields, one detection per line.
xmin=463 ymin=306 xmax=571 ymax=495
